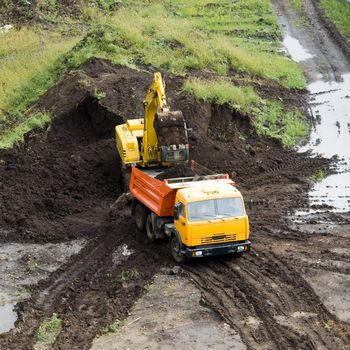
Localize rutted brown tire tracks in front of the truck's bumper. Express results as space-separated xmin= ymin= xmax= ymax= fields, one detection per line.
xmin=186 ymin=251 xmax=350 ymax=350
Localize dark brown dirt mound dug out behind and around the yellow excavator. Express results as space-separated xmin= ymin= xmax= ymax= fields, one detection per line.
xmin=0 ymin=59 xmax=328 ymax=241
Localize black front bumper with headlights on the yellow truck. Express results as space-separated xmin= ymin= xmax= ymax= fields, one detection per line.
xmin=183 ymin=240 xmax=251 ymax=258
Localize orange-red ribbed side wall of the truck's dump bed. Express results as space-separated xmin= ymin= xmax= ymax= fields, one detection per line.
xmin=130 ymin=167 xmax=177 ymax=216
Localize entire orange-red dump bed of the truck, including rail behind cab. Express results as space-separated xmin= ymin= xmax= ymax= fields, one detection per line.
xmin=130 ymin=167 xmax=235 ymax=216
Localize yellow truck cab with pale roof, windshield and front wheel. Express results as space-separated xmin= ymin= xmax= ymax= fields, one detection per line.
xmin=166 ymin=182 xmax=250 ymax=262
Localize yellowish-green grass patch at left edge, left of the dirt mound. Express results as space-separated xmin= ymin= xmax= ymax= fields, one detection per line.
xmin=0 ymin=27 xmax=79 ymax=148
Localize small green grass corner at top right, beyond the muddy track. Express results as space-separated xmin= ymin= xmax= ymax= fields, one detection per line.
xmin=320 ymin=0 xmax=350 ymax=42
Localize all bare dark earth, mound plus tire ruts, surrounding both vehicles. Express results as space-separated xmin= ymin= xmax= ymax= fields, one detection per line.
xmin=0 ymin=51 xmax=350 ymax=350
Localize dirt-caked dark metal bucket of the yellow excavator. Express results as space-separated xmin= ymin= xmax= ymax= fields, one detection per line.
xmin=154 ymin=111 xmax=189 ymax=163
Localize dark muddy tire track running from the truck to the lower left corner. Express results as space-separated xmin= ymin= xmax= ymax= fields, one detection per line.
xmin=0 ymin=216 xmax=167 ymax=350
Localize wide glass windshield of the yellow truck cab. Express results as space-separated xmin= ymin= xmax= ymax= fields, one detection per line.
xmin=188 ymin=197 xmax=245 ymax=221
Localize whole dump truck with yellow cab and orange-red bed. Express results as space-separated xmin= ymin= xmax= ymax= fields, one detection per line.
xmin=130 ymin=167 xmax=251 ymax=263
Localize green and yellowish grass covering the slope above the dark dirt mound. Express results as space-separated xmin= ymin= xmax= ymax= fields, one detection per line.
xmin=0 ymin=0 xmax=306 ymax=147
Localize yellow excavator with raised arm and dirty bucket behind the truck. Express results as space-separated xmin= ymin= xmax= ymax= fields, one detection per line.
xmin=115 ymin=72 xmax=189 ymax=167
